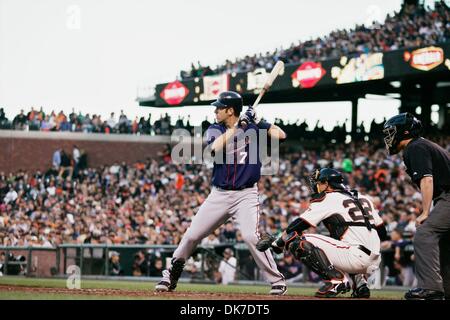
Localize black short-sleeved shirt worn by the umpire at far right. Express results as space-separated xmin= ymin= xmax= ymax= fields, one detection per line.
xmin=403 ymin=138 xmax=450 ymax=200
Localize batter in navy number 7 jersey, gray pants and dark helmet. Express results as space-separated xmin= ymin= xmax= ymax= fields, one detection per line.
xmin=155 ymin=91 xmax=287 ymax=295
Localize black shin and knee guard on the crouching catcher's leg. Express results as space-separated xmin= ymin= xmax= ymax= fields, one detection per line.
xmin=289 ymin=239 xmax=344 ymax=280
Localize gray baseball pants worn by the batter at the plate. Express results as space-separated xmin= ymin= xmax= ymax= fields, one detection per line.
xmin=173 ymin=186 xmax=285 ymax=285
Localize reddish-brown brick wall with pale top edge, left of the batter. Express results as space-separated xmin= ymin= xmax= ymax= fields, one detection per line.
xmin=0 ymin=130 xmax=170 ymax=173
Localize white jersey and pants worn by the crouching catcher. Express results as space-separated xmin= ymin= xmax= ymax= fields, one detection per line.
xmin=300 ymin=192 xmax=383 ymax=274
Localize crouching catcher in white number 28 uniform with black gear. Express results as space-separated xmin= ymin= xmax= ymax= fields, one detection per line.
xmin=256 ymin=168 xmax=387 ymax=298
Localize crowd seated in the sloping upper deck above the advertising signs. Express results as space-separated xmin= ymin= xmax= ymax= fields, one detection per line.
xmin=180 ymin=1 xmax=450 ymax=79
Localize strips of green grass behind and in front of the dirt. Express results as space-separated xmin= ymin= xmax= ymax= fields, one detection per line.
xmin=0 ymin=277 xmax=404 ymax=300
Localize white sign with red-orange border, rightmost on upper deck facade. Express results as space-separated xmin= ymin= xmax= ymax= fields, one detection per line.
xmin=403 ymin=47 xmax=444 ymax=71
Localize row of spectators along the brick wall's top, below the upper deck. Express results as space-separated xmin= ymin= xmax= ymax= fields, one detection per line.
xmin=0 ymin=107 xmax=450 ymax=143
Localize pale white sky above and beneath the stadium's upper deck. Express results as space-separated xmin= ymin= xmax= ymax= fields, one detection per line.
xmin=0 ymin=0 xmax=414 ymax=129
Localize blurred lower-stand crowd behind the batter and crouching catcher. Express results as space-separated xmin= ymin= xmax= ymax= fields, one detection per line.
xmin=0 ymin=135 xmax=450 ymax=284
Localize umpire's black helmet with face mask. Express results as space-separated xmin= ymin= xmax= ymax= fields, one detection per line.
xmin=383 ymin=112 xmax=422 ymax=154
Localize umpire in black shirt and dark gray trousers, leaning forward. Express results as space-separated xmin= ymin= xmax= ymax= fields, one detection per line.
xmin=383 ymin=113 xmax=450 ymax=300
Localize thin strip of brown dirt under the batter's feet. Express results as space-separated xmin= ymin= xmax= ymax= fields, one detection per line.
xmin=0 ymin=285 xmax=324 ymax=300
